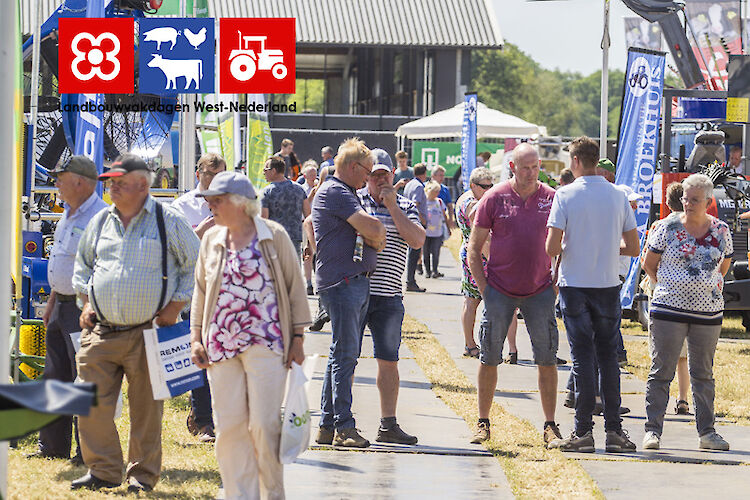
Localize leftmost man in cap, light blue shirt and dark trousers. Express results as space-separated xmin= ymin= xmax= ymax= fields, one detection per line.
xmin=34 ymin=156 xmax=107 ymax=463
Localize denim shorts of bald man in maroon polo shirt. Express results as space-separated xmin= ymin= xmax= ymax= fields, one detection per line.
xmin=479 ymin=285 xmax=559 ymax=366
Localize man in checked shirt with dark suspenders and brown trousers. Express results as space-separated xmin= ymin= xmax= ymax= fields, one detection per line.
xmin=72 ymin=154 xmax=200 ymax=492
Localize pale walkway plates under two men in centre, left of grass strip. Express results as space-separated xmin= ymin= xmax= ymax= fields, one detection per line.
xmin=285 ymin=294 xmax=513 ymax=499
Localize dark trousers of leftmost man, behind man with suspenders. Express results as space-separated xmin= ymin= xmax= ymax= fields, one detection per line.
xmin=39 ymin=301 xmax=81 ymax=458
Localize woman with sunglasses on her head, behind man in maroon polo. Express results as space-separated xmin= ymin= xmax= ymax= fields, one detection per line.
xmin=456 ymin=167 xmax=493 ymax=358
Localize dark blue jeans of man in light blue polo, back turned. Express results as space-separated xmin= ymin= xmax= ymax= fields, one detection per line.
xmin=560 ymin=285 xmax=622 ymax=436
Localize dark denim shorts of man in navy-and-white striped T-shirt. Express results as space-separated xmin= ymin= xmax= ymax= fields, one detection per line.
xmin=362 ymin=295 xmax=404 ymax=361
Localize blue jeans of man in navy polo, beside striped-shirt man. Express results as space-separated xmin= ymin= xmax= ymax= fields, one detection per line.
xmin=318 ymin=275 xmax=370 ymax=429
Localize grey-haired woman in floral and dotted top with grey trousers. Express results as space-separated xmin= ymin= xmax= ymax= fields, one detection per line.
xmin=643 ymin=174 xmax=733 ymax=450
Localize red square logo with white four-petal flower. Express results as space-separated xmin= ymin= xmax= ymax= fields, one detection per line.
xmin=58 ymin=17 xmax=135 ymax=94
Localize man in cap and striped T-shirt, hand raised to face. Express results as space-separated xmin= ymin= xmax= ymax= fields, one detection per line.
xmin=358 ymin=149 xmax=425 ymax=445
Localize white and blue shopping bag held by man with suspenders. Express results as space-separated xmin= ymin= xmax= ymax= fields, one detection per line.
xmin=143 ymin=320 xmax=203 ymax=399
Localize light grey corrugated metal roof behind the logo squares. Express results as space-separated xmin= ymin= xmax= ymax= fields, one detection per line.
xmin=21 ymin=0 xmax=503 ymax=48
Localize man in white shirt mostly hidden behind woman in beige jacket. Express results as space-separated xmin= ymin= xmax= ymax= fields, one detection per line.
xmin=172 ymin=153 xmax=227 ymax=442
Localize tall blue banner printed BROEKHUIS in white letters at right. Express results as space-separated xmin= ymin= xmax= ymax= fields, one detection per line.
xmin=615 ymin=48 xmax=671 ymax=309
